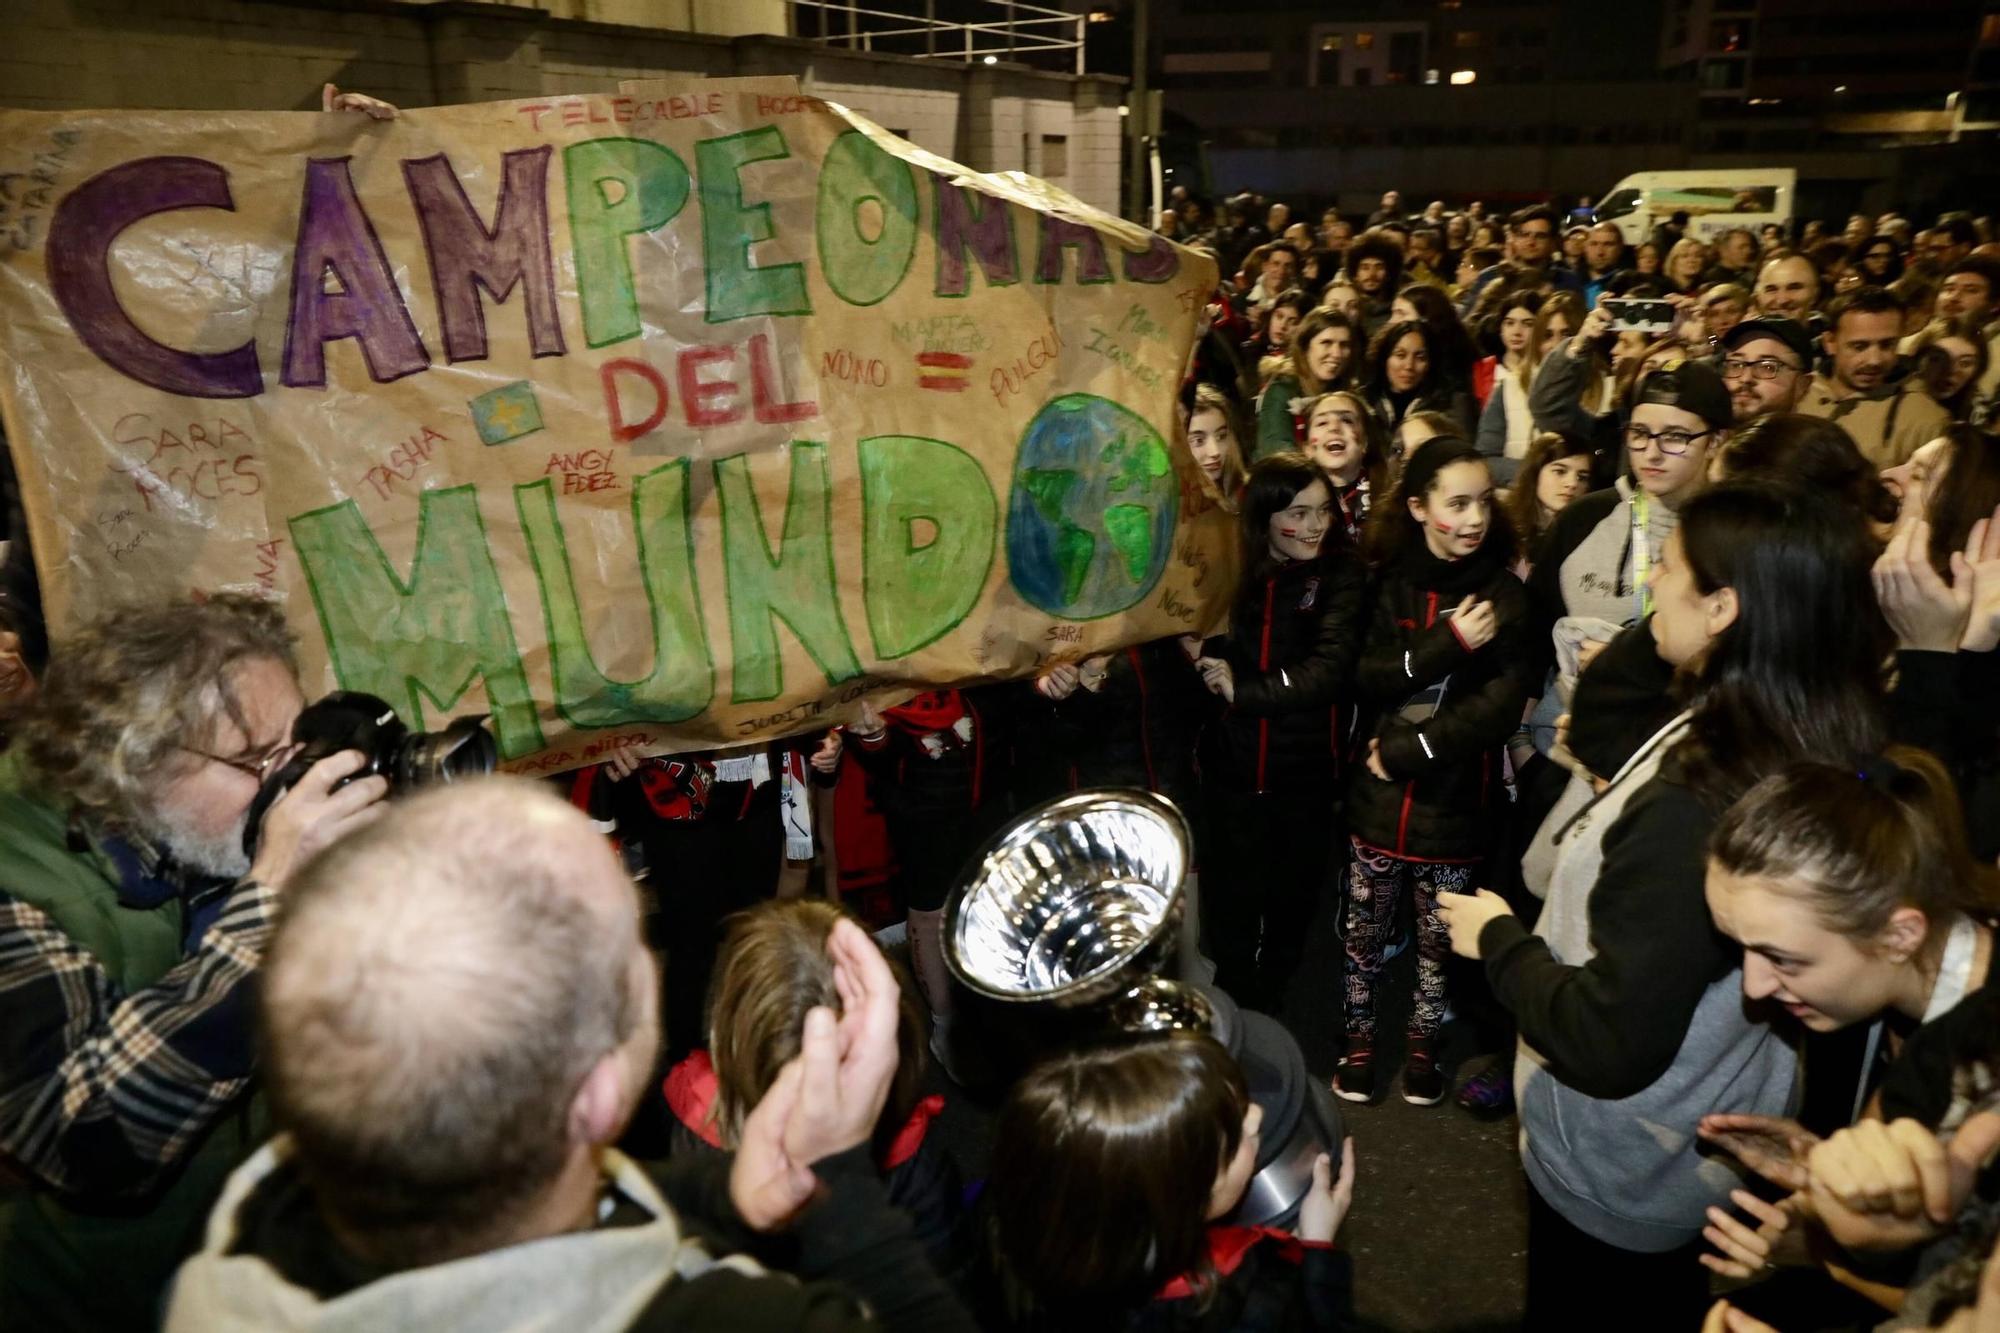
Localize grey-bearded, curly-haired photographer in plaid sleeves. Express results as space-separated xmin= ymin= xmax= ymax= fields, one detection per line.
xmin=0 ymin=594 xmax=384 ymax=1333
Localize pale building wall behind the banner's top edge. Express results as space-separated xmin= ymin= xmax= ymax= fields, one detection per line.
xmin=0 ymin=0 xmax=1124 ymax=212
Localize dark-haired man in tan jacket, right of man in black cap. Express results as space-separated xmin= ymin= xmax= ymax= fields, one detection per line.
xmin=1798 ymin=286 xmax=1952 ymax=468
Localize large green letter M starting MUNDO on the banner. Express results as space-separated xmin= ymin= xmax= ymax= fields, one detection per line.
xmin=292 ymin=486 xmax=542 ymax=759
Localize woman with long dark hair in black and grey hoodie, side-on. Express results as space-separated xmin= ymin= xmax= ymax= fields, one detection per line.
xmin=1444 ymin=482 xmax=1890 ymax=1329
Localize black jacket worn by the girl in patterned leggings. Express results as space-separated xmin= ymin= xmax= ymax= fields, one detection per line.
xmin=1348 ymin=544 xmax=1534 ymax=861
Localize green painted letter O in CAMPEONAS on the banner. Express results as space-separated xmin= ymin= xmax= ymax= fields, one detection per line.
xmin=814 ymin=130 xmax=916 ymax=306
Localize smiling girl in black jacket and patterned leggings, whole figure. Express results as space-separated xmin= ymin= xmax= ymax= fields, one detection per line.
xmin=1334 ymin=436 xmax=1532 ymax=1107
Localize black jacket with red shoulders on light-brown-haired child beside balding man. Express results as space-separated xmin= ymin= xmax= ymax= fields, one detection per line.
xmin=664 ymin=1051 xmax=964 ymax=1265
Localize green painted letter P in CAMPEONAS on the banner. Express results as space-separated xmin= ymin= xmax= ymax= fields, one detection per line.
xmin=562 ymin=138 xmax=688 ymax=346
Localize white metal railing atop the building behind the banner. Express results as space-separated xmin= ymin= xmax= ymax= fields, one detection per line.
xmin=790 ymin=0 xmax=1090 ymax=74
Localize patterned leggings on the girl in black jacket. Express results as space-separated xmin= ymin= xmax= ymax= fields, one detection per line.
xmin=1346 ymin=839 xmax=1480 ymax=1041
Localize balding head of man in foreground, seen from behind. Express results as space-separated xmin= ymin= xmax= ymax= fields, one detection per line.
xmin=262 ymin=779 xmax=656 ymax=1255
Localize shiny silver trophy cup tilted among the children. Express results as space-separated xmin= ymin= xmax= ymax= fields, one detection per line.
xmin=944 ymin=789 xmax=1342 ymax=1225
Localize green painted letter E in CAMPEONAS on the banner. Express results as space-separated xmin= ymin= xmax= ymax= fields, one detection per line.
xmin=694 ymin=124 xmax=812 ymax=324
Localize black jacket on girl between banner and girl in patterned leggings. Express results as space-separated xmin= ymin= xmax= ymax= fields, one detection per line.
xmin=1200 ymin=550 xmax=1366 ymax=793
